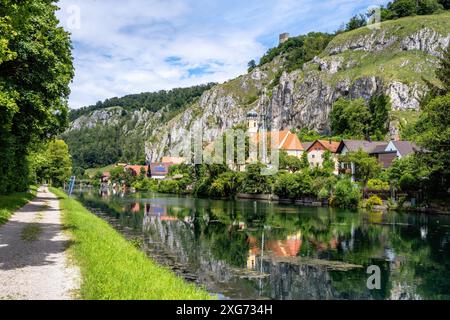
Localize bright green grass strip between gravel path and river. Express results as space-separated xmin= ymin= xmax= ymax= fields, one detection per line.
xmin=51 ymin=188 xmax=213 ymax=300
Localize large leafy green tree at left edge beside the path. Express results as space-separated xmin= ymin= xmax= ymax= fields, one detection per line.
xmin=0 ymin=0 xmax=74 ymax=193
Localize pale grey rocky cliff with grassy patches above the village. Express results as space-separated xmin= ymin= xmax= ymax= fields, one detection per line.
xmin=67 ymin=12 xmax=450 ymax=162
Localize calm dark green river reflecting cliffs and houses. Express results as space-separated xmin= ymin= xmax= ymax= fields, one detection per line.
xmin=77 ymin=192 xmax=450 ymax=299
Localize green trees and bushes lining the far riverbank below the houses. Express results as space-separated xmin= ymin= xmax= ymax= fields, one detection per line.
xmin=90 ymin=42 xmax=450 ymax=208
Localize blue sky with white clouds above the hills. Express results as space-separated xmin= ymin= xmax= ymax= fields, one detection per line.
xmin=58 ymin=0 xmax=387 ymax=108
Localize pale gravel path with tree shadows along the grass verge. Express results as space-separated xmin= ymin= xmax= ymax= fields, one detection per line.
xmin=0 ymin=187 xmax=80 ymax=300
